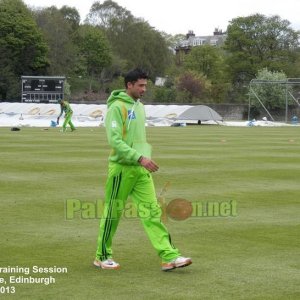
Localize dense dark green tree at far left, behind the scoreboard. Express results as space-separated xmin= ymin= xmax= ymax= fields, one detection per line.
xmin=0 ymin=0 xmax=48 ymax=100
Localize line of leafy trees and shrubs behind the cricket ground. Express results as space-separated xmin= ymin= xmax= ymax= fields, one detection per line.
xmin=0 ymin=0 xmax=300 ymax=109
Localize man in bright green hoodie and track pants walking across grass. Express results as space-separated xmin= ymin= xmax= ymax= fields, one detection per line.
xmin=93 ymin=69 xmax=192 ymax=271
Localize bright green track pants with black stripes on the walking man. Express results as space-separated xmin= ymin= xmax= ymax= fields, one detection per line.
xmin=96 ymin=163 xmax=180 ymax=262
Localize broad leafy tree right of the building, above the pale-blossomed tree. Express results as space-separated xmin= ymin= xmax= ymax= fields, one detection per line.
xmin=225 ymin=14 xmax=299 ymax=85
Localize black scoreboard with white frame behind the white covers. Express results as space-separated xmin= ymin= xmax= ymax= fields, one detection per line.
xmin=21 ymin=76 xmax=65 ymax=103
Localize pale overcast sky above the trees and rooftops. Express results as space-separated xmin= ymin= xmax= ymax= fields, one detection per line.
xmin=23 ymin=0 xmax=300 ymax=35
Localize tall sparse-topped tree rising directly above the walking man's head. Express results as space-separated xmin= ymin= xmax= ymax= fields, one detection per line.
xmin=86 ymin=0 xmax=172 ymax=79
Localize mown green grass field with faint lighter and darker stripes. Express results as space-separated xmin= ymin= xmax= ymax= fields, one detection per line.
xmin=0 ymin=126 xmax=300 ymax=300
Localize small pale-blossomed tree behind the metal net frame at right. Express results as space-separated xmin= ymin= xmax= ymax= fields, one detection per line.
xmin=250 ymin=68 xmax=291 ymax=110
